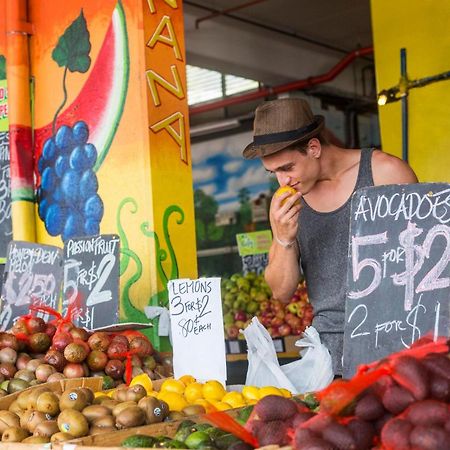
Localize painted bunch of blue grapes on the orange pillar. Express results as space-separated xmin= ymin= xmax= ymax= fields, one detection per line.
xmin=38 ymin=121 xmax=104 ymax=241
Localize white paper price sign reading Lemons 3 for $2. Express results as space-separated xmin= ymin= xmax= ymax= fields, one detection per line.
xmin=167 ymin=278 xmax=227 ymax=384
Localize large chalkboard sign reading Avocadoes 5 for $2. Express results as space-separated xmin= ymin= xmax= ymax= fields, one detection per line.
xmin=343 ymin=183 xmax=450 ymax=378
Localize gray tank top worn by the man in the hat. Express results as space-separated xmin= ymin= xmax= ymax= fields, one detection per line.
xmin=298 ymin=148 xmax=374 ymax=375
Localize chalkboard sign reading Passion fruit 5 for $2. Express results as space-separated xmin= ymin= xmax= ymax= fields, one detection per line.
xmin=62 ymin=234 xmax=120 ymax=330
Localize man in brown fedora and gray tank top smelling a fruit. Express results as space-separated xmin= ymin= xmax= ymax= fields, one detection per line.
xmin=243 ymin=98 xmax=417 ymax=375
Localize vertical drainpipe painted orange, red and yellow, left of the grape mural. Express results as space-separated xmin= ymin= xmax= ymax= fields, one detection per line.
xmin=6 ymin=0 xmax=36 ymax=241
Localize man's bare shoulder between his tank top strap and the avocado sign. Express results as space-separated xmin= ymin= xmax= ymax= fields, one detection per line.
xmin=372 ymin=150 xmax=417 ymax=186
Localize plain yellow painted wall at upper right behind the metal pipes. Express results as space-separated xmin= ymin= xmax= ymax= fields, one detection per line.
xmin=371 ymin=0 xmax=450 ymax=182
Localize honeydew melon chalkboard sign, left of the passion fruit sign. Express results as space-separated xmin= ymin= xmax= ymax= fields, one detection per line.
xmin=0 ymin=241 xmax=63 ymax=331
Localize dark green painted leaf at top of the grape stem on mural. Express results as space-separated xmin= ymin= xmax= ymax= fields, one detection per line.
xmin=52 ymin=10 xmax=91 ymax=73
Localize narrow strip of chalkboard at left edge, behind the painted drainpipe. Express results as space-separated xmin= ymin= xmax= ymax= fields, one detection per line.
xmin=0 ymin=131 xmax=12 ymax=258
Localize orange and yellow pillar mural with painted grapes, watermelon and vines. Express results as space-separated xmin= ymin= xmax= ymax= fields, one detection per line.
xmin=0 ymin=0 xmax=197 ymax=346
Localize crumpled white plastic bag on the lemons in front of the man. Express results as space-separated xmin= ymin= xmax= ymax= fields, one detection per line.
xmin=241 ymin=317 xmax=333 ymax=394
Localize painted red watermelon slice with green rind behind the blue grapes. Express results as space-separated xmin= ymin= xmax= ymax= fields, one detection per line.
xmin=34 ymin=0 xmax=130 ymax=171
